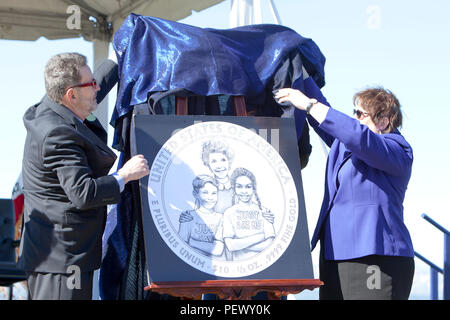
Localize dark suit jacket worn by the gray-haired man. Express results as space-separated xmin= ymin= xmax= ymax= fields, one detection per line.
xmin=20 ymin=60 xmax=120 ymax=273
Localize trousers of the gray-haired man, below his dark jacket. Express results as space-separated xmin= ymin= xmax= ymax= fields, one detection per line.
xmin=26 ymin=271 xmax=94 ymax=300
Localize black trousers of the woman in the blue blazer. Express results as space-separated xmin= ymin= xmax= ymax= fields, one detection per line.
xmin=319 ymin=251 xmax=414 ymax=300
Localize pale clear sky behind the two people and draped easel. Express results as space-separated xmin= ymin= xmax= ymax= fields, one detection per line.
xmin=0 ymin=0 xmax=450 ymax=299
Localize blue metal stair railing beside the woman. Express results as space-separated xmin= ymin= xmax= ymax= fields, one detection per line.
xmin=414 ymin=213 xmax=450 ymax=300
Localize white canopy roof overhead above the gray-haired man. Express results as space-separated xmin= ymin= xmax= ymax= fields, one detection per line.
xmin=0 ymin=0 xmax=224 ymax=130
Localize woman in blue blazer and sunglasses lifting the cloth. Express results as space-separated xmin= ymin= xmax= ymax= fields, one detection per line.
xmin=275 ymin=88 xmax=414 ymax=299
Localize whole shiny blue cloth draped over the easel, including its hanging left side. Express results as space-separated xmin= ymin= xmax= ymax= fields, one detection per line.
xmin=100 ymin=14 xmax=325 ymax=299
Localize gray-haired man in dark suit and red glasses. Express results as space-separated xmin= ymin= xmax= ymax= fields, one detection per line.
xmin=20 ymin=53 xmax=149 ymax=299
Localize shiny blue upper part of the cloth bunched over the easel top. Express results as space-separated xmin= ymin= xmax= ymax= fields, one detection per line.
xmin=111 ymin=14 xmax=325 ymax=125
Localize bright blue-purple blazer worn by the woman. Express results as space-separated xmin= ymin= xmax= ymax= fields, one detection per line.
xmin=309 ymin=108 xmax=414 ymax=260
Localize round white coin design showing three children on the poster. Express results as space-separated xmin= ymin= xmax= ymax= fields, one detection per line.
xmin=148 ymin=121 xmax=299 ymax=278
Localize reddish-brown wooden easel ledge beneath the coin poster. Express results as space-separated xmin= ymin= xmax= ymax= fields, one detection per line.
xmin=145 ymin=279 xmax=323 ymax=300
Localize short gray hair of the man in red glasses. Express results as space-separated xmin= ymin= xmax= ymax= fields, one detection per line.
xmin=44 ymin=52 xmax=87 ymax=102
